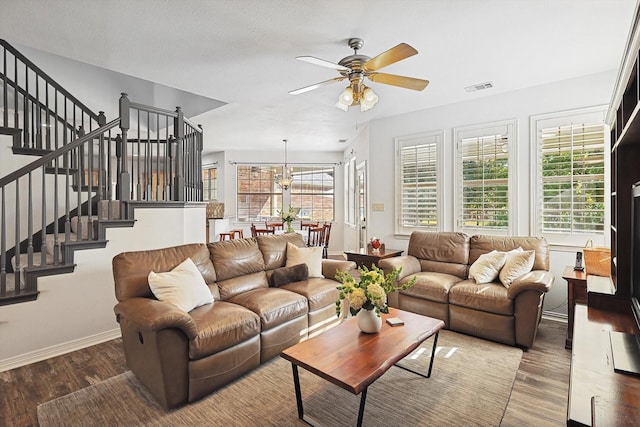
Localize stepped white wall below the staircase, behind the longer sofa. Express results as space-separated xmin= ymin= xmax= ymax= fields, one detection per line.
xmin=0 ymin=205 xmax=205 ymax=371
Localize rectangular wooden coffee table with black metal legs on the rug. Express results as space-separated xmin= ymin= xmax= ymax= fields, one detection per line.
xmin=280 ymin=308 xmax=444 ymax=426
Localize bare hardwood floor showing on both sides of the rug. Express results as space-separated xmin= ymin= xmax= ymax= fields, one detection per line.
xmin=0 ymin=319 xmax=571 ymax=427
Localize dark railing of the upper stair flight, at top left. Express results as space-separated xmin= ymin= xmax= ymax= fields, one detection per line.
xmin=0 ymin=39 xmax=99 ymax=151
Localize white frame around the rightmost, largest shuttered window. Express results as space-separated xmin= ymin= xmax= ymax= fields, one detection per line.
xmin=529 ymin=105 xmax=611 ymax=248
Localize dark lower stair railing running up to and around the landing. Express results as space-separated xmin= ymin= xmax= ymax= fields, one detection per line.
xmin=0 ymin=94 xmax=203 ymax=305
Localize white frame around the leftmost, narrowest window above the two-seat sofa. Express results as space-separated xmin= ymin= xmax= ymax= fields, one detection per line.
xmin=394 ymin=130 xmax=444 ymax=235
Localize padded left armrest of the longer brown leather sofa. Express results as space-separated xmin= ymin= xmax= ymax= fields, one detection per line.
xmin=113 ymin=298 xmax=198 ymax=339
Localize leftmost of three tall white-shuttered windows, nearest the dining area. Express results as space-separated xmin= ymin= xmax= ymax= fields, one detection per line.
xmin=396 ymin=131 xmax=443 ymax=234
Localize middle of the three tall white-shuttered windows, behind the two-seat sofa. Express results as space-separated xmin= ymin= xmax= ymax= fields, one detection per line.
xmin=454 ymin=121 xmax=516 ymax=234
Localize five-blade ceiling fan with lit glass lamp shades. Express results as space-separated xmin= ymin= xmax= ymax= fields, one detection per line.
xmin=289 ymin=38 xmax=429 ymax=111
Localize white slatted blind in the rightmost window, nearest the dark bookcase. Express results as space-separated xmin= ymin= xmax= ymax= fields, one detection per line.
xmin=539 ymin=123 xmax=607 ymax=236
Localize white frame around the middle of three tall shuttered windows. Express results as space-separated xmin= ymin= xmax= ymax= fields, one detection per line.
xmin=453 ymin=119 xmax=518 ymax=236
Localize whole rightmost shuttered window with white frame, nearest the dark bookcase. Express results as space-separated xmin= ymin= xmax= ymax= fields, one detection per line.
xmin=532 ymin=108 xmax=609 ymax=246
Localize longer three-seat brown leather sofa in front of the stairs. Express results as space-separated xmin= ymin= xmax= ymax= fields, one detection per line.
xmin=113 ymin=233 xmax=355 ymax=408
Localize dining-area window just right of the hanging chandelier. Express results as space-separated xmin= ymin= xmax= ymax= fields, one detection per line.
xmin=290 ymin=166 xmax=335 ymax=221
